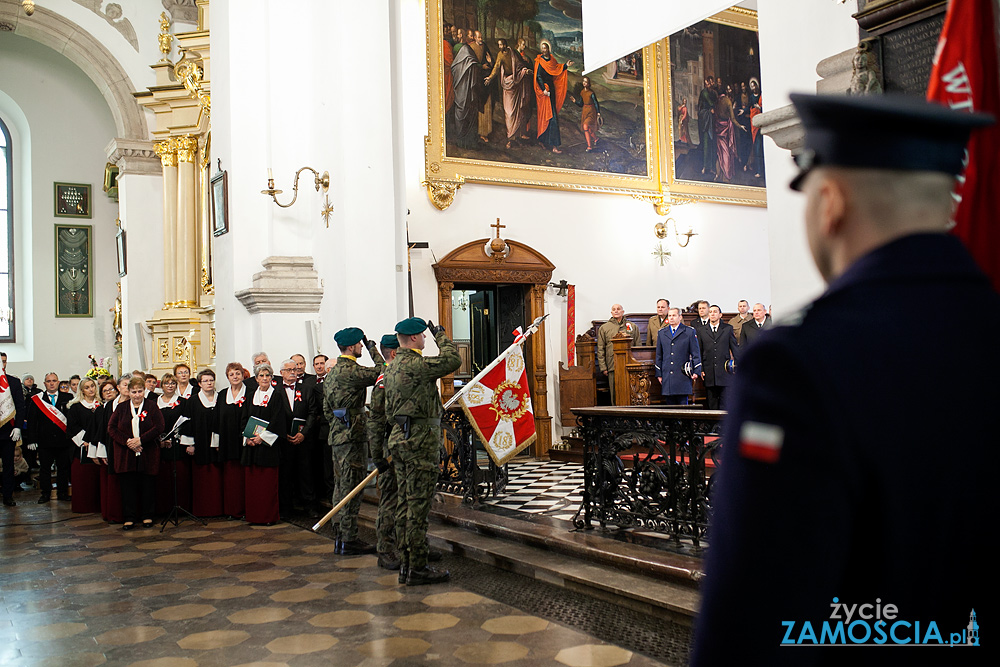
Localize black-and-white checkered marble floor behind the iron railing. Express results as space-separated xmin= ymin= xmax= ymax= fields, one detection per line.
xmin=487 ymin=459 xmax=583 ymax=521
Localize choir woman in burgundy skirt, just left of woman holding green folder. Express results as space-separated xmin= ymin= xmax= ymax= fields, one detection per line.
xmin=215 ymin=361 xmax=250 ymax=519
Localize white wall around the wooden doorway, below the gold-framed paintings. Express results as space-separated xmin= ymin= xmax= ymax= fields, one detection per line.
xmin=399 ymin=0 xmax=772 ymax=434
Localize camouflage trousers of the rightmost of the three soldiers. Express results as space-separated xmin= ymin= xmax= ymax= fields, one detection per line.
xmin=389 ymin=426 xmax=441 ymax=569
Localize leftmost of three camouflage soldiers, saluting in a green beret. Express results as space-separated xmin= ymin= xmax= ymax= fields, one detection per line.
xmin=323 ymin=327 xmax=385 ymax=555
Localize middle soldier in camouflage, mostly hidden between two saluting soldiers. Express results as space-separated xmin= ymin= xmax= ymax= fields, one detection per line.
xmin=368 ymin=334 xmax=399 ymax=570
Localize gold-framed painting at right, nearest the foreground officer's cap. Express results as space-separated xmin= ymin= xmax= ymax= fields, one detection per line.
xmin=658 ymin=7 xmax=767 ymax=206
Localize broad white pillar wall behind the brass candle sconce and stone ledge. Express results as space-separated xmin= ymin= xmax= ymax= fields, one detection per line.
xmin=211 ymin=0 xmax=398 ymax=364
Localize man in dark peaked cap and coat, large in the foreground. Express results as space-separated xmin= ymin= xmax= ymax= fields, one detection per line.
xmin=692 ymin=95 xmax=1000 ymax=667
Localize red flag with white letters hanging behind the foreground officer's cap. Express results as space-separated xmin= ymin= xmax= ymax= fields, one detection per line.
xmin=927 ymin=0 xmax=1000 ymax=290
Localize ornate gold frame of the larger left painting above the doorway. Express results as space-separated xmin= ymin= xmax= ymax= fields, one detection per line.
xmin=423 ymin=0 xmax=664 ymax=211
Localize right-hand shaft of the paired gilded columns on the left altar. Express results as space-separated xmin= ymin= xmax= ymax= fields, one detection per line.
xmin=174 ymin=135 xmax=199 ymax=308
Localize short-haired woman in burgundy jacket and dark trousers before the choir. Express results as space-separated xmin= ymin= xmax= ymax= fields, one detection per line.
xmin=108 ymin=377 xmax=163 ymax=530
